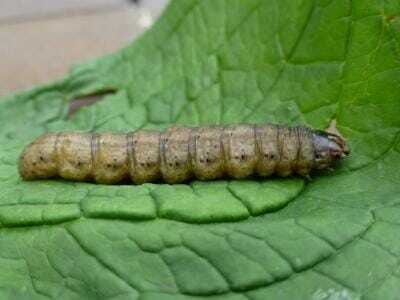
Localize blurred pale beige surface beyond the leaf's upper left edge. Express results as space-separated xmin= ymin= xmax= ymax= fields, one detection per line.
xmin=0 ymin=0 xmax=168 ymax=97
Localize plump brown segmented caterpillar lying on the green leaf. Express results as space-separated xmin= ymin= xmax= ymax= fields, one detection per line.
xmin=19 ymin=124 xmax=349 ymax=184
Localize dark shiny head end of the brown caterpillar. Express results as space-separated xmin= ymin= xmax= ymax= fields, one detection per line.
xmin=313 ymin=131 xmax=350 ymax=170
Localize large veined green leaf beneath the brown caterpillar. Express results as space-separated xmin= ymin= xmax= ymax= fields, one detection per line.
xmin=0 ymin=0 xmax=400 ymax=300
